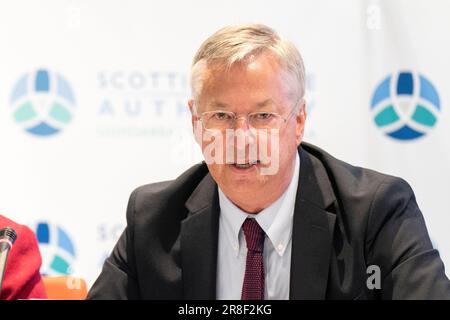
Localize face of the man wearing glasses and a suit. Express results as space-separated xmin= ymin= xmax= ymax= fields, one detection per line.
xmin=189 ymin=54 xmax=306 ymax=208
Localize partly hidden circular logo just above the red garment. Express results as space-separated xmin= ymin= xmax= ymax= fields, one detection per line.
xmin=36 ymin=222 xmax=75 ymax=275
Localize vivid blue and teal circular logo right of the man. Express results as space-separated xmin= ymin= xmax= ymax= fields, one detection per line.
xmin=370 ymin=71 xmax=441 ymax=140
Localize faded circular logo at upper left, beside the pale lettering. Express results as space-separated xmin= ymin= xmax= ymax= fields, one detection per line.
xmin=10 ymin=69 xmax=75 ymax=136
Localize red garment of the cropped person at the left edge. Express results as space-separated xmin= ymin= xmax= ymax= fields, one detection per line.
xmin=0 ymin=215 xmax=47 ymax=300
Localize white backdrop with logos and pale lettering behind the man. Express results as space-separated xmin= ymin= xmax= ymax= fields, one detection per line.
xmin=0 ymin=0 xmax=450 ymax=285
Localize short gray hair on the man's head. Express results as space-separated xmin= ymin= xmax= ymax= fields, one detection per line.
xmin=191 ymin=24 xmax=305 ymax=106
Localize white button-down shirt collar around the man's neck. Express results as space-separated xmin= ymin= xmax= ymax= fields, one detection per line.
xmin=218 ymin=153 xmax=300 ymax=256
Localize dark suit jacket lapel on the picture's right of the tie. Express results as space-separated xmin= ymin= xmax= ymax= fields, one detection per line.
xmin=290 ymin=148 xmax=336 ymax=299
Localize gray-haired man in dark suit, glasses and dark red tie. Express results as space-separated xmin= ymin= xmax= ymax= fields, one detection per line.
xmin=89 ymin=25 xmax=450 ymax=299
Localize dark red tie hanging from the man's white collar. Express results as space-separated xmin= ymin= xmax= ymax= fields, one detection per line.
xmin=241 ymin=218 xmax=264 ymax=300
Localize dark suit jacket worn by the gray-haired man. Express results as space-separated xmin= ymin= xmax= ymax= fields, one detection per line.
xmin=88 ymin=143 xmax=450 ymax=299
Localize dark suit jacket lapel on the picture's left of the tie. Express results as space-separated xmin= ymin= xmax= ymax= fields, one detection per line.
xmin=181 ymin=174 xmax=220 ymax=299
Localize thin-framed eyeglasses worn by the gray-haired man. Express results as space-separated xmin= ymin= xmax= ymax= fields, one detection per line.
xmin=198 ymin=101 xmax=299 ymax=130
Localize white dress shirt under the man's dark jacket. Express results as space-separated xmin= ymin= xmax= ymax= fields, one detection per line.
xmin=216 ymin=153 xmax=300 ymax=300
